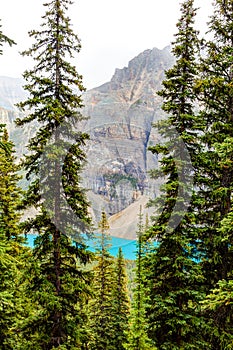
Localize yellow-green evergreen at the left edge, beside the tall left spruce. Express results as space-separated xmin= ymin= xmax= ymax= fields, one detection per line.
xmin=0 ymin=129 xmax=27 ymax=350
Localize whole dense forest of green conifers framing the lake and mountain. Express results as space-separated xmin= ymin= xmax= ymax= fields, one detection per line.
xmin=0 ymin=0 xmax=233 ymax=350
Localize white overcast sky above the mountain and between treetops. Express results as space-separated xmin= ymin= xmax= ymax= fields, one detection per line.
xmin=0 ymin=0 xmax=212 ymax=88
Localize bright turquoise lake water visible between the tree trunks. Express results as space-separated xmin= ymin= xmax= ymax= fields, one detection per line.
xmin=27 ymin=235 xmax=136 ymax=260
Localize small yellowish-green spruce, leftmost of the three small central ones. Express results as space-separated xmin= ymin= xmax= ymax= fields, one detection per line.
xmin=90 ymin=212 xmax=115 ymax=350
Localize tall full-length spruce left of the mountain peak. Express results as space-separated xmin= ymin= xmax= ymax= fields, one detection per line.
xmin=17 ymin=0 xmax=91 ymax=350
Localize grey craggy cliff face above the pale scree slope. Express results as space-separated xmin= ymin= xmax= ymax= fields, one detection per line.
xmin=81 ymin=48 xmax=174 ymax=221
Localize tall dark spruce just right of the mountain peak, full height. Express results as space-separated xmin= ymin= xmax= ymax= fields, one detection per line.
xmin=146 ymin=0 xmax=208 ymax=350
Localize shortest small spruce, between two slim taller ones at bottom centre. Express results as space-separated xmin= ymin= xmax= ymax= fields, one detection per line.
xmin=112 ymin=248 xmax=129 ymax=350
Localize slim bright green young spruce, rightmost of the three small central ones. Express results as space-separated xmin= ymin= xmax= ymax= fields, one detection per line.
xmin=125 ymin=208 xmax=156 ymax=350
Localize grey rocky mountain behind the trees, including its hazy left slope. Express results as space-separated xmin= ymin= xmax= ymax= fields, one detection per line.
xmin=0 ymin=47 xmax=174 ymax=238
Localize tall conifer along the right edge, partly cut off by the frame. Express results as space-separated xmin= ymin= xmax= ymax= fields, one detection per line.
xmin=196 ymin=0 xmax=233 ymax=291
